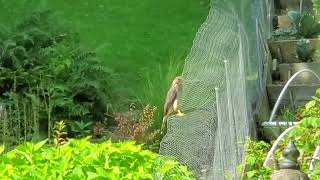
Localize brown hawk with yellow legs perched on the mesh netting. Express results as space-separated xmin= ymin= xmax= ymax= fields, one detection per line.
xmin=161 ymin=76 xmax=184 ymax=134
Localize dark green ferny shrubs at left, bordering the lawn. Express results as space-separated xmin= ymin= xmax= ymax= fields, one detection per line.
xmin=0 ymin=11 xmax=112 ymax=144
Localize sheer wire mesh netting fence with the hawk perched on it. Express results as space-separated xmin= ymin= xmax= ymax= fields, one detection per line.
xmin=160 ymin=0 xmax=271 ymax=179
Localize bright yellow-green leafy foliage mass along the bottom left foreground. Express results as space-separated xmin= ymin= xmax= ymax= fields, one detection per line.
xmin=0 ymin=138 xmax=194 ymax=180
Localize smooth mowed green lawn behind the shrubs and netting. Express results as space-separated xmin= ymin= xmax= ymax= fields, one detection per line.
xmin=0 ymin=0 xmax=209 ymax=103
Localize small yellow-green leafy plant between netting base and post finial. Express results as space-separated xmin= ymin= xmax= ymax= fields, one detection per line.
xmin=238 ymin=139 xmax=271 ymax=179
